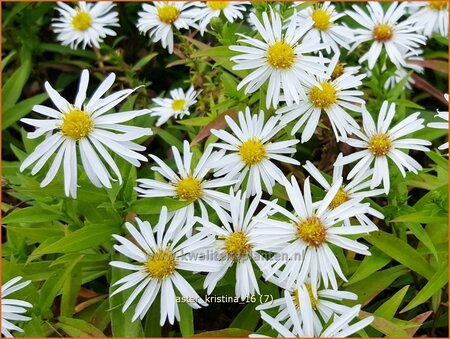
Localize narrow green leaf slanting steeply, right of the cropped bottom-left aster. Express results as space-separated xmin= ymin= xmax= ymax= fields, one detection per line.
xmin=38 ymin=255 xmax=83 ymax=314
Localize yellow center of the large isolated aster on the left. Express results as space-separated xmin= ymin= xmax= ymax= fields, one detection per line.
xmin=61 ymin=108 xmax=94 ymax=140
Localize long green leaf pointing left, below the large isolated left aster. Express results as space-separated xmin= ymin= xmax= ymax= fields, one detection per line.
xmin=28 ymin=224 xmax=120 ymax=261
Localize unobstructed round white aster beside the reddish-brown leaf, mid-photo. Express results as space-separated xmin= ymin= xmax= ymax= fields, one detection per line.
xmin=211 ymin=107 xmax=300 ymax=195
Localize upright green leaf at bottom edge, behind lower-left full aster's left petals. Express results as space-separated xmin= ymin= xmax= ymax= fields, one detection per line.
xmin=109 ymin=254 xmax=144 ymax=338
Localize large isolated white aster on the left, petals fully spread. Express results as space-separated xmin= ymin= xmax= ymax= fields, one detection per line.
xmin=20 ymin=70 xmax=152 ymax=198
